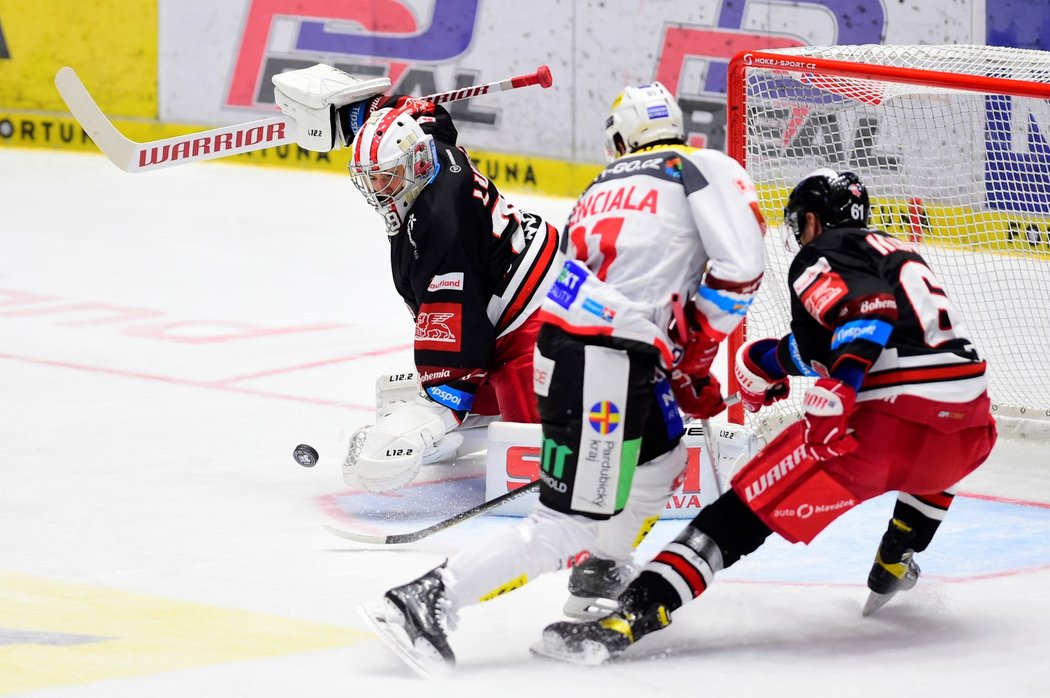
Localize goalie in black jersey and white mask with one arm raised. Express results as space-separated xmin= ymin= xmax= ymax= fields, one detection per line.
xmin=274 ymin=65 xmax=561 ymax=492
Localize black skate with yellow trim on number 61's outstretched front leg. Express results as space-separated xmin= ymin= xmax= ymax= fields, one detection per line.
xmin=530 ymin=590 xmax=671 ymax=665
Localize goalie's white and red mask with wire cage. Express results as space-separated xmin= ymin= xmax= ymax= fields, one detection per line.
xmin=348 ymin=109 xmax=438 ymax=235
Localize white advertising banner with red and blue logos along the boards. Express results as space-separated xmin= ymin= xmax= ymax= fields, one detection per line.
xmin=161 ymin=0 xmax=986 ymax=164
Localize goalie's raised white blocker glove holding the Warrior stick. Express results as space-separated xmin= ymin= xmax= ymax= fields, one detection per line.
xmin=273 ymin=63 xmax=391 ymax=152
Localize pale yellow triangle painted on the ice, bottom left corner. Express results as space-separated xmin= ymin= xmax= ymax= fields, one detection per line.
xmin=0 ymin=573 xmax=368 ymax=695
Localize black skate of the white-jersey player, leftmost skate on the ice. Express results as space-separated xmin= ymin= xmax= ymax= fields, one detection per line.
xmin=358 ymin=565 xmax=456 ymax=677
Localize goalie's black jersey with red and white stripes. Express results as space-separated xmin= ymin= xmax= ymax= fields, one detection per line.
xmin=391 ymin=132 xmax=559 ymax=411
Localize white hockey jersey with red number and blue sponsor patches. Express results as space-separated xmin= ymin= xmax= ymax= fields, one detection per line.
xmin=541 ymin=145 xmax=764 ymax=368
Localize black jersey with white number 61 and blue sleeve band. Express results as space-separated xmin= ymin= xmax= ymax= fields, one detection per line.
xmin=777 ymin=228 xmax=987 ymax=402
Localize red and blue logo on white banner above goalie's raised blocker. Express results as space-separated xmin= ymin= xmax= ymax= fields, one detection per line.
xmin=226 ymin=0 xmax=482 ymax=109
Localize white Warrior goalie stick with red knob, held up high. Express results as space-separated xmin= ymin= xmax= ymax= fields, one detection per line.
xmin=55 ymin=65 xmax=552 ymax=172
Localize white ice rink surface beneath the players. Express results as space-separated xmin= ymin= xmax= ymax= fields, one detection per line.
xmin=6 ymin=149 xmax=1050 ymax=698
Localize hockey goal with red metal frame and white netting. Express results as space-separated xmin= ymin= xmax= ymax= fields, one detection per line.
xmin=728 ymin=45 xmax=1050 ymax=439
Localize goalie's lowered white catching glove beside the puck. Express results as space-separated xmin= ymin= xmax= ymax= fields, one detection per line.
xmin=342 ymin=396 xmax=463 ymax=492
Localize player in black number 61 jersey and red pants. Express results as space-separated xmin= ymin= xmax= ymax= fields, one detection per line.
xmin=533 ymin=169 xmax=995 ymax=663
